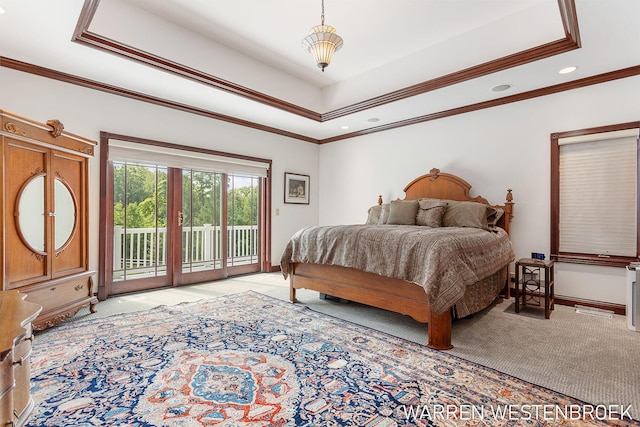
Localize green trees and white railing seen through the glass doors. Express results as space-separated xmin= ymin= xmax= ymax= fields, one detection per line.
xmin=113 ymin=163 xmax=259 ymax=277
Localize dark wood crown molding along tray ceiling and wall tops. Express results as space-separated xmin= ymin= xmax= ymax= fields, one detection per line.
xmin=0 ymin=0 xmax=640 ymax=144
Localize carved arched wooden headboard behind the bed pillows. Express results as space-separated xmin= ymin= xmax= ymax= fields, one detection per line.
xmin=378 ymin=168 xmax=514 ymax=233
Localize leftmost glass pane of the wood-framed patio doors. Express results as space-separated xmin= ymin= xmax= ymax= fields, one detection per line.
xmin=113 ymin=162 xmax=167 ymax=282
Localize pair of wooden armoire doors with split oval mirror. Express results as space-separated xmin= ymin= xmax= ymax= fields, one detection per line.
xmin=4 ymin=139 xmax=87 ymax=289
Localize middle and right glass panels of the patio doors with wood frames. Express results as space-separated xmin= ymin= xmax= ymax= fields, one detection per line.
xmin=176 ymin=170 xmax=260 ymax=284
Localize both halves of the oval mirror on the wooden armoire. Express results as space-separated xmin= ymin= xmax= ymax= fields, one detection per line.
xmin=16 ymin=174 xmax=76 ymax=254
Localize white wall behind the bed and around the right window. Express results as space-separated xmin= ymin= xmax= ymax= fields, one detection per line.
xmin=320 ymin=77 xmax=640 ymax=304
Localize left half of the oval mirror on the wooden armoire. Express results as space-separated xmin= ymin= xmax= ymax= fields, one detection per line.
xmin=16 ymin=175 xmax=45 ymax=254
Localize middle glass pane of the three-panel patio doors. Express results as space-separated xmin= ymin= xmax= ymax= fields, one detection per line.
xmin=181 ymin=170 xmax=224 ymax=273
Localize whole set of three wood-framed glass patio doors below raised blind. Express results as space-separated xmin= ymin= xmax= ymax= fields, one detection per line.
xmin=104 ymin=161 xmax=264 ymax=299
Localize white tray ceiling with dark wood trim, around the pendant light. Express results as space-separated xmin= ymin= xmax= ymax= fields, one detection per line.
xmin=0 ymin=0 xmax=640 ymax=143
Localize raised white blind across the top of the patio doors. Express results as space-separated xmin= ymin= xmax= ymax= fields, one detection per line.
xmin=109 ymin=139 xmax=270 ymax=178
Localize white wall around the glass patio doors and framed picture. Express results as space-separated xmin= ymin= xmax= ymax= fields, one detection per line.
xmin=0 ymin=68 xmax=319 ymax=269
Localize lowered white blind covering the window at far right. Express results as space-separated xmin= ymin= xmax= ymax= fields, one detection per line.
xmin=558 ymin=129 xmax=638 ymax=257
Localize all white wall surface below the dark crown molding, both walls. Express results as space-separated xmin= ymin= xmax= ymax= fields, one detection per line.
xmin=0 ymin=68 xmax=640 ymax=304
